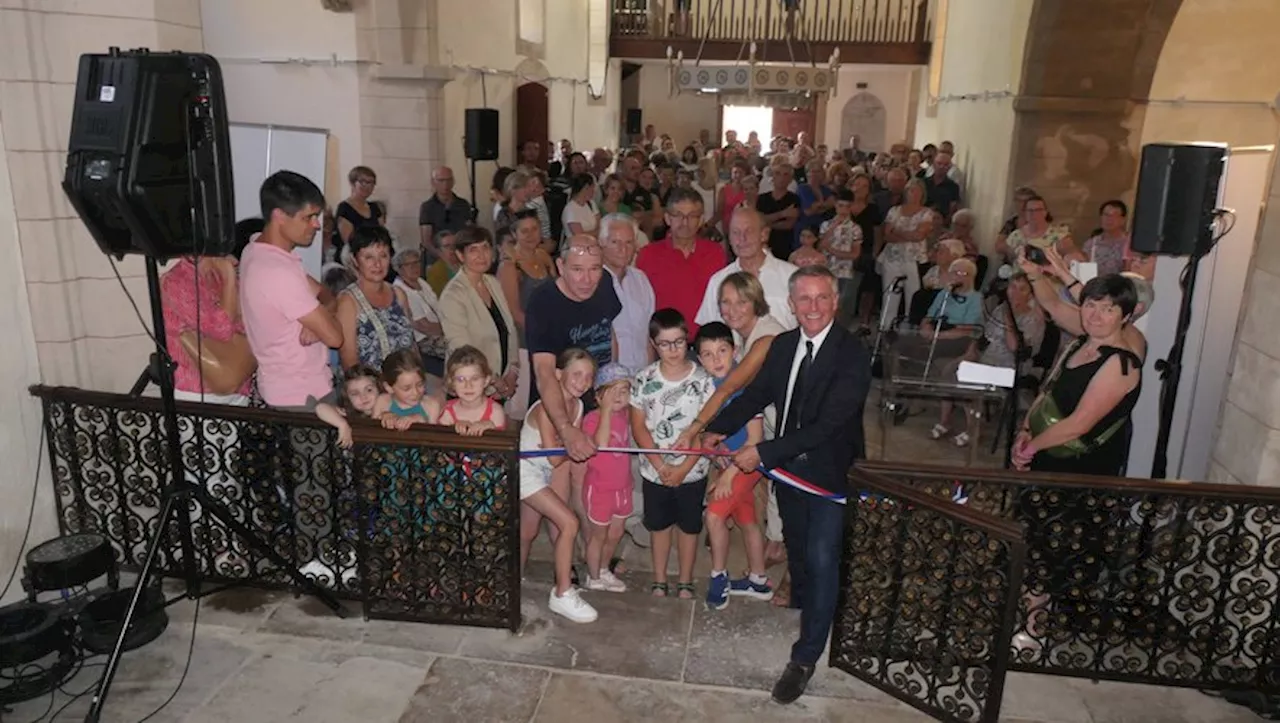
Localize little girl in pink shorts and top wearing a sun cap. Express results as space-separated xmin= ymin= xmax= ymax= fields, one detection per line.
xmin=582 ymin=363 xmax=632 ymax=592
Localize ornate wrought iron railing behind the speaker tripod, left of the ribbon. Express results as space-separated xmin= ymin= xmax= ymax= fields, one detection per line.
xmin=31 ymin=386 xmax=520 ymax=630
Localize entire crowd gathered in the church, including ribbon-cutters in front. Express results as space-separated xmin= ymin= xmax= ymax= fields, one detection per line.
xmin=163 ymin=127 xmax=1152 ymax=701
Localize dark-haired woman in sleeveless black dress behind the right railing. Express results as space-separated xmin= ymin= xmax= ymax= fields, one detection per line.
xmin=1012 ymin=274 xmax=1142 ymax=642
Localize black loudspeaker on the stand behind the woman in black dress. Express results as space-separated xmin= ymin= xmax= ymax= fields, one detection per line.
xmin=1133 ymin=143 xmax=1226 ymax=256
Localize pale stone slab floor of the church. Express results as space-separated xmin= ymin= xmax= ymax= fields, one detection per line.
xmin=0 ymin=393 xmax=1260 ymax=723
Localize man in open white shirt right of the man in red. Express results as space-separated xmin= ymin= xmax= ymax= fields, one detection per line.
xmin=695 ymin=207 xmax=796 ymax=329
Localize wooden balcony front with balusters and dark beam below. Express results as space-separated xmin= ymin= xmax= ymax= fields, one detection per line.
xmin=611 ymin=0 xmax=932 ymax=63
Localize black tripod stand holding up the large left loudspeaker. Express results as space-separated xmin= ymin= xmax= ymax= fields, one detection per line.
xmin=84 ymin=256 xmax=346 ymax=723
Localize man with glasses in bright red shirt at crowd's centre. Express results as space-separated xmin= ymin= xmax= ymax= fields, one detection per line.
xmin=636 ymin=188 xmax=728 ymax=338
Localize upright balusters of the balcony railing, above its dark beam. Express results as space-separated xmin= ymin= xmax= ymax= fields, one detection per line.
xmin=612 ymin=0 xmax=929 ymax=44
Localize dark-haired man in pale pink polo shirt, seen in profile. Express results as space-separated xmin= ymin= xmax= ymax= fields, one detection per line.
xmin=241 ymin=170 xmax=342 ymax=412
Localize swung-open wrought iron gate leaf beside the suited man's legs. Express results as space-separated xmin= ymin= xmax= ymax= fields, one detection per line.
xmin=831 ymin=470 xmax=1025 ymax=722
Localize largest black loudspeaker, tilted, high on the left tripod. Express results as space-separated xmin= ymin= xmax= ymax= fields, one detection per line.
xmin=63 ymin=47 xmax=236 ymax=260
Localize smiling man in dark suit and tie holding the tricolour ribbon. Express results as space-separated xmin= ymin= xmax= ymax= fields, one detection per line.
xmin=703 ymin=266 xmax=872 ymax=703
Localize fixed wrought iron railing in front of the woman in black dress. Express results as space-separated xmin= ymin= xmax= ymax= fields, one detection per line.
xmin=859 ymin=463 xmax=1280 ymax=695
